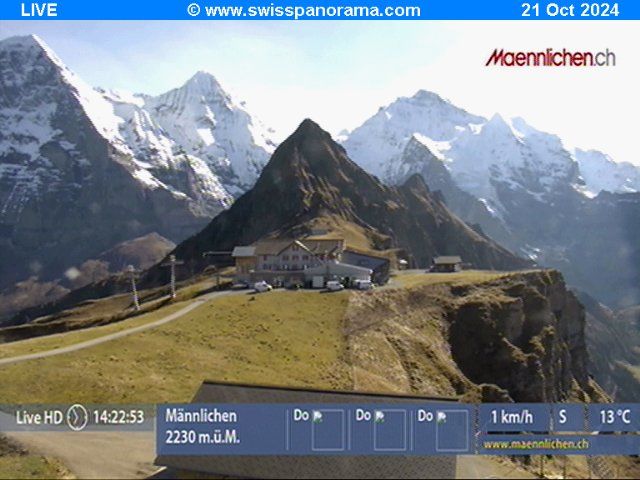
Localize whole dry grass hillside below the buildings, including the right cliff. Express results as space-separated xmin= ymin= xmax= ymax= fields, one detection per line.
xmin=0 ymin=271 xmax=640 ymax=478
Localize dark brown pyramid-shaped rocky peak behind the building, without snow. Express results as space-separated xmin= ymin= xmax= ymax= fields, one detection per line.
xmin=160 ymin=119 xmax=530 ymax=278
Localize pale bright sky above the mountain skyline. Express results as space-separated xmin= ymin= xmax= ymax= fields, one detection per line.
xmin=0 ymin=21 xmax=640 ymax=164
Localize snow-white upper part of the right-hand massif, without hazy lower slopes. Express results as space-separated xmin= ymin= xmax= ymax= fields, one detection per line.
xmin=341 ymin=90 xmax=640 ymax=212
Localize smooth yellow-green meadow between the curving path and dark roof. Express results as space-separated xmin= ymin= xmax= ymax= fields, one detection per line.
xmin=0 ymin=291 xmax=352 ymax=403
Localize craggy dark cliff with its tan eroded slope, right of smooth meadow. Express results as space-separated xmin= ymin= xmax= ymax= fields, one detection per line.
xmin=345 ymin=270 xmax=608 ymax=402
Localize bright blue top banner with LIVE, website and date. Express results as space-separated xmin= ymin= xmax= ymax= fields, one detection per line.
xmin=0 ymin=0 xmax=640 ymax=21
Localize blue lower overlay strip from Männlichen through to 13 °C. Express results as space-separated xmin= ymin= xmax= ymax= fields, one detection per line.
xmin=156 ymin=403 xmax=640 ymax=456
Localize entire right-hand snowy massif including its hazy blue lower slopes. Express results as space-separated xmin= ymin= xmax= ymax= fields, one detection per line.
xmin=341 ymin=91 xmax=640 ymax=305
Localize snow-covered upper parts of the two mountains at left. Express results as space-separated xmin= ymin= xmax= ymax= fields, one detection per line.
xmin=0 ymin=35 xmax=275 ymax=222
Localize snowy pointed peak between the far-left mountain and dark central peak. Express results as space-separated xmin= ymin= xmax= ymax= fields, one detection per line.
xmin=94 ymin=63 xmax=275 ymax=199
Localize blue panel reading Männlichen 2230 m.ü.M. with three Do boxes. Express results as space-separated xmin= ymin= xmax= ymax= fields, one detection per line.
xmin=156 ymin=403 xmax=475 ymax=455
